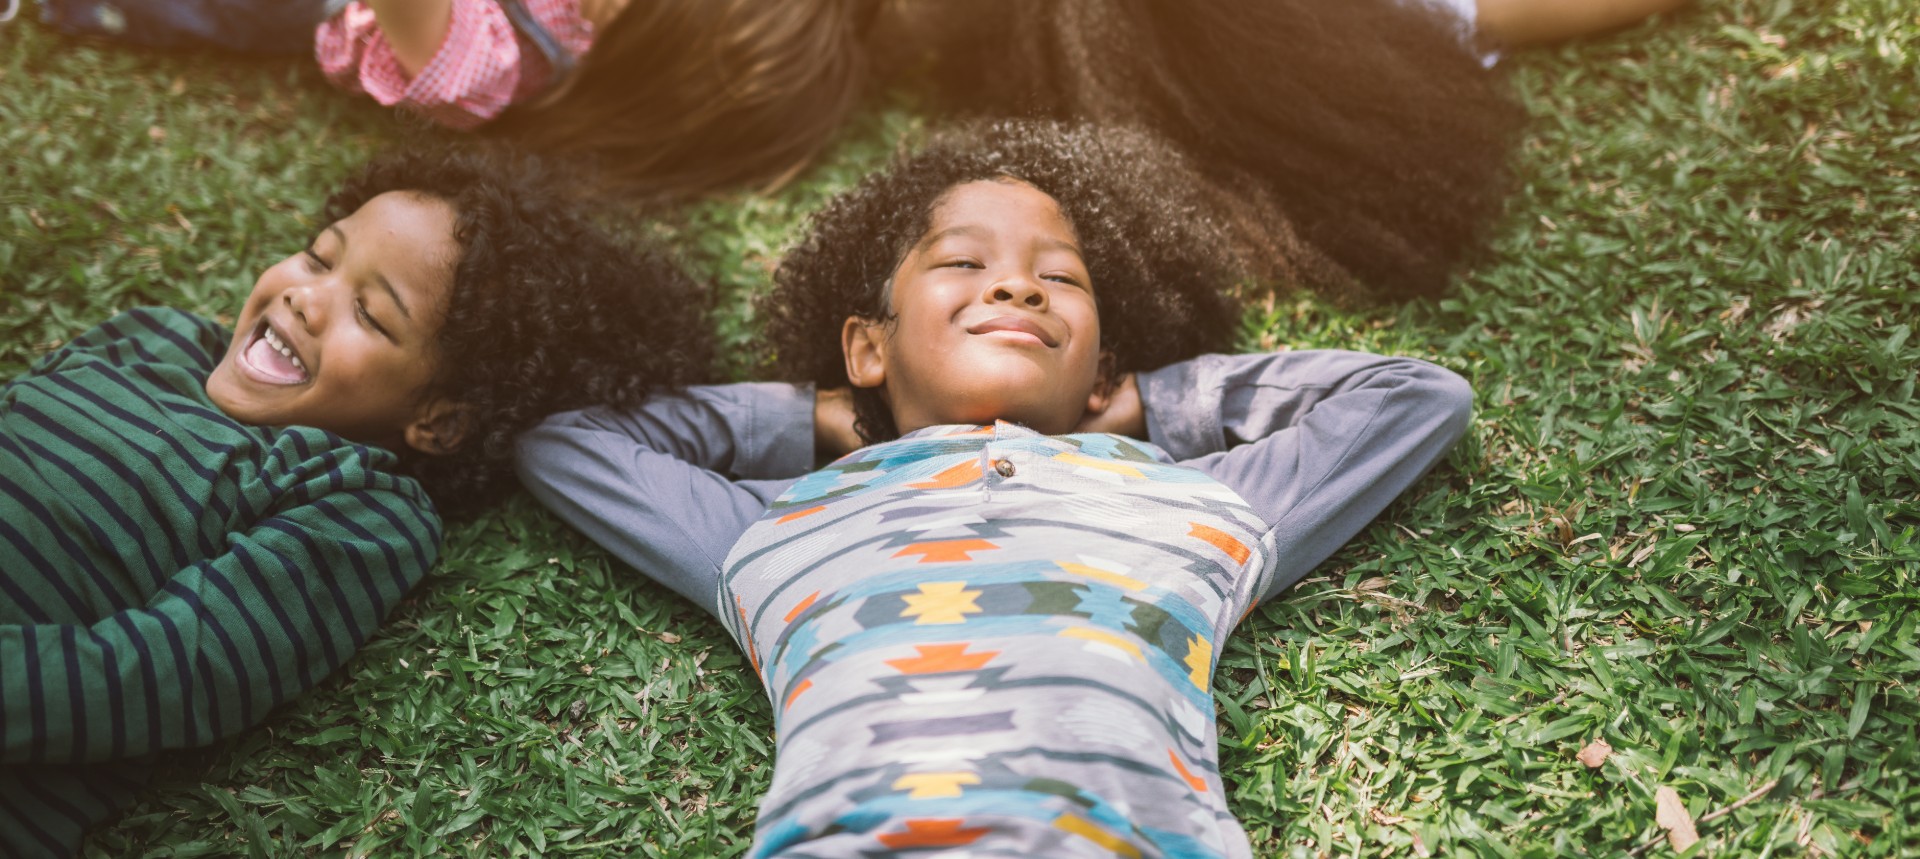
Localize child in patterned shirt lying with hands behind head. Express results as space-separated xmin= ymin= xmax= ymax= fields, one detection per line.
xmin=520 ymin=123 xmax=1471 ymax=857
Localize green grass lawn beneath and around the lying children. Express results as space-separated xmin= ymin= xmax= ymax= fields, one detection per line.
xmin=0 ymin=0 xmax=1920 ymax=857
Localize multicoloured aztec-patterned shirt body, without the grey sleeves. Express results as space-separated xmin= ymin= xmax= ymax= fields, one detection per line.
xmin=724 ymin=423 xmax=1273 ymax=857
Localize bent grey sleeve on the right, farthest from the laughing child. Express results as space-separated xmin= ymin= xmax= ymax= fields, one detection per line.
xmin=1140 ymin=352 xmax=1473 ymax=600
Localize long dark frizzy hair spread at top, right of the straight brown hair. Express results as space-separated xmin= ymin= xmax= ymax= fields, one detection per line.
xmin=881 ymin=0 xmax=1524 ymax=298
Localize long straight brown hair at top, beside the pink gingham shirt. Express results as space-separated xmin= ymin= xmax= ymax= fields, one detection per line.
xmin=493 ymin=0 xmax=868 ymax=200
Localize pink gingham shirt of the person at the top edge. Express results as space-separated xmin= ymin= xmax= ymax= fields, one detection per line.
xmin=313 ymin=0 xmax=593 ymax=131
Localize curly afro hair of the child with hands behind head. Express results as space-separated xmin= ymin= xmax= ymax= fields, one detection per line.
xmin=762 ymin=121 xmax=1327 ymax=444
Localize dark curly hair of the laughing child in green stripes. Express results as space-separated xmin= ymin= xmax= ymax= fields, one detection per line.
xmin=323 ymin=150 xmax=712 ymax=513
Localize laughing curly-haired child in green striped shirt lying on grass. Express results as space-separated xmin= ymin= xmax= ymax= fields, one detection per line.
xmin=0 ymin=147 xmax=707 ymax=855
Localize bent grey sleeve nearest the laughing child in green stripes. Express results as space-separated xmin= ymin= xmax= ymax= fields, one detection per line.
xmin=516 ymin=382 xmax=814 ymax=617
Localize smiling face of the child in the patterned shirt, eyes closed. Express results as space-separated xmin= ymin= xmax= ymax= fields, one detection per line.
xmin=841 ymin=181 xmax=1106 ymax=434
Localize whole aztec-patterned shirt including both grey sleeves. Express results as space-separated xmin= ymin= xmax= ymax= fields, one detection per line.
xmin=518 ymin=350 xmax=1473 ymax=859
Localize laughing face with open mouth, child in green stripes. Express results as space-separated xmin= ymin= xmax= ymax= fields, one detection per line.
xmin=207 ymin=192 xmax=459 ymax=452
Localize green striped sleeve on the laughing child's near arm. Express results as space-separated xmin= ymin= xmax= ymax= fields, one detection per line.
xmin=0 ymin=484 xmax=440 ymax=767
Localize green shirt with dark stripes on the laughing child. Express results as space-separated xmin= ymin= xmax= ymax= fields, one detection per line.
xmin=0 ymin=309 xmax=440 ymax=855
